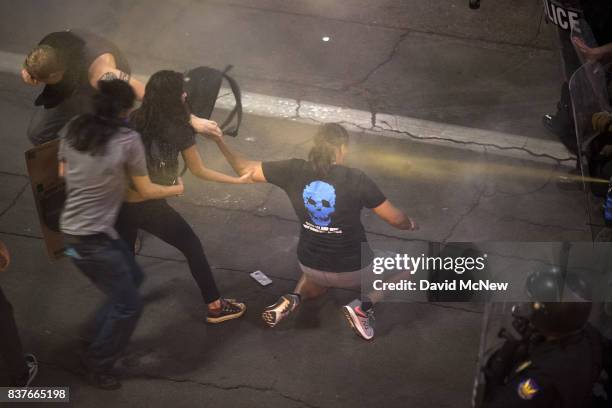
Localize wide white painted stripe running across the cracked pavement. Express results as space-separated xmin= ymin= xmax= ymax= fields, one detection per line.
xmin=0 ymin=51 xmax=575 ymax=167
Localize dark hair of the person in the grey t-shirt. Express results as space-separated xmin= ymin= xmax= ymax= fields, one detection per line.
xmin=66 ymin=79 xmax=135 ymax=156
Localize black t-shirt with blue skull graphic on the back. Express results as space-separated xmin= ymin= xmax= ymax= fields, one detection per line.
xmin=262 ymin=159 xmax=386 ymax=272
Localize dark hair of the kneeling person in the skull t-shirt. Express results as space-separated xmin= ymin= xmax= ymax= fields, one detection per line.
xmin=308 ymin=123 xmax=349 ymax=176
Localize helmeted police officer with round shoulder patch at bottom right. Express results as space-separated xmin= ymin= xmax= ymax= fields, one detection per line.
xmin=483 ymin=272 xmax=602 ymax=408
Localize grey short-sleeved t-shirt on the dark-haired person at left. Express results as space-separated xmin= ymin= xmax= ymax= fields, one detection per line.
xmin=58 ymin=128 xmax=147 ymax=239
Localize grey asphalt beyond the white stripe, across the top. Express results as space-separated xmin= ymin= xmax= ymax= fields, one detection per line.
xmin=0 ymin=0 xmax=561 ymax=138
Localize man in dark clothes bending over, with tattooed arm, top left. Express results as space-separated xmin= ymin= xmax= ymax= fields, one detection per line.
xmin=21 ymin=30 xmax=144 ymax=145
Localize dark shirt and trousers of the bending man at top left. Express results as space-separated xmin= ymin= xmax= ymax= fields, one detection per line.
xmin=28 ymin=30 xmax=131 ymax=145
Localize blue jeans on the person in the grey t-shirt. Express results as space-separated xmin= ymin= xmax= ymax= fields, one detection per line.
xmin=65 ymin=234 xmax=144 ymax=372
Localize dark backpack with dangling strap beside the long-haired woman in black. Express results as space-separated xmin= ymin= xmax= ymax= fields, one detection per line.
xmin=184 ymin=65 xmax=242 ymax=136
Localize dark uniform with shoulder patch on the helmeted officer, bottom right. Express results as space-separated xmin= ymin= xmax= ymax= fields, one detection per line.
xmin=483 ymin=326 xmax=602 ymax=408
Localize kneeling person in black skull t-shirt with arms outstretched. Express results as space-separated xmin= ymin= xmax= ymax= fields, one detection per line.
xmin=209 ymin=123 xmax=417 ymax=340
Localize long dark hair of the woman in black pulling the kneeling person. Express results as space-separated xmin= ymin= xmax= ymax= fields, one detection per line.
xmin=130 ymin=70 xmax=189 ymax=145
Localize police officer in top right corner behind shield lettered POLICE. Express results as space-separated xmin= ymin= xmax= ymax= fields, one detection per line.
xmin=542 ymin=0 xmax=612 ymax=153
